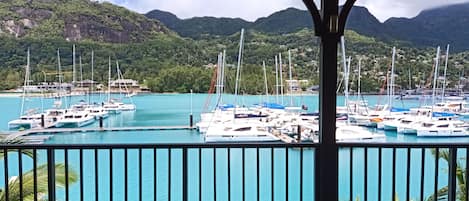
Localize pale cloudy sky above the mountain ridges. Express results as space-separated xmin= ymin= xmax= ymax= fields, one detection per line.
xmin=100 ymin=0 xmax=469 ymax=21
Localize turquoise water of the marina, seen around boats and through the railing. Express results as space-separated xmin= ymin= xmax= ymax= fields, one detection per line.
xmin=0 ymin=94 xmax=469 ymax=200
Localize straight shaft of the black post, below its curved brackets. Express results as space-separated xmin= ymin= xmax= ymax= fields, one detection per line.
xmin=315 ymin=33 xmax=339 ymax=201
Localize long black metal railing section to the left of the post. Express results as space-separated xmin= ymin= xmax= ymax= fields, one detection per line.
xmin=0 ymin=143 xmax=316 ymax=200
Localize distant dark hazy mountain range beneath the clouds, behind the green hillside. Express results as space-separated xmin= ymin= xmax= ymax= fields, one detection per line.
xmin=146 ymin=3 xmax=469 ymax=52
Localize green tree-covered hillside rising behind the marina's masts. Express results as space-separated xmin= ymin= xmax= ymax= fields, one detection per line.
xmin=0 ymin=0 xmax=469 ymax=94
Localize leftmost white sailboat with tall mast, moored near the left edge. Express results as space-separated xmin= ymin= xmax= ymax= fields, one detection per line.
xmin=8 ymin=49 xmax=42 ymax=129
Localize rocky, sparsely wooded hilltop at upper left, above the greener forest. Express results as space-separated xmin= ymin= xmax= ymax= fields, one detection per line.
xmin=0 ymin=0 xmax=173 ymax=43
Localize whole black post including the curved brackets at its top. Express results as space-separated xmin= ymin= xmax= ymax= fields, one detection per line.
xmin=303 ymin=0 xmax=356 ymax=201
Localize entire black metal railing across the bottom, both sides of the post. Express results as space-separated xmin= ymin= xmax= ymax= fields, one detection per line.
xmin=0 ymin=143 xmax=469 ymax=201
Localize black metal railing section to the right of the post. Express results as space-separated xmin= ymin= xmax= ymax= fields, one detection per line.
xmin=339 ymin=143 xmax=469 ymax=201
